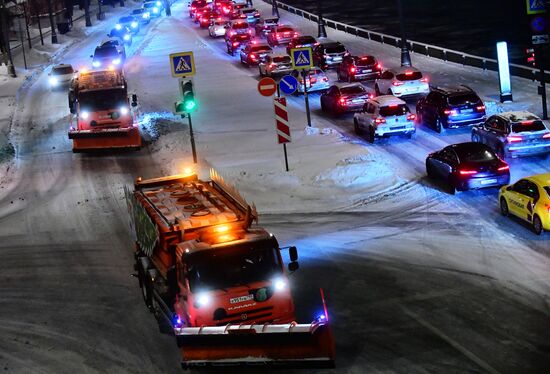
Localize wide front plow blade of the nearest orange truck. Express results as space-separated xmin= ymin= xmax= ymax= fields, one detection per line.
xmin=179 ymin=322 xmax=335 ymax=369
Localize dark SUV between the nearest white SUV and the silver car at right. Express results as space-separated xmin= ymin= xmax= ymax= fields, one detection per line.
xmin=416 ymin=85 xmax=486 ymax=133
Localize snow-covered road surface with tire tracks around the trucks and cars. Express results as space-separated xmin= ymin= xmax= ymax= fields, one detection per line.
xmin=0 ymin=1 xmax=550 ymax=373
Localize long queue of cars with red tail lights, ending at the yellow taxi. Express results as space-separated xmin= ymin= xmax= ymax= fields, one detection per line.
xmin=189 ymin=0 xmax=550 ymax=234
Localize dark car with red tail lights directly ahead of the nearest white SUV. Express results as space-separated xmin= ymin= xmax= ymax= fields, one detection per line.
xmin=321 ymin=83 xmax=369 ymax=114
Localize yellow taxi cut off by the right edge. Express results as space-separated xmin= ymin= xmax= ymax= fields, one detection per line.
xmin=498 ymin=173 xmax=550 ymax=235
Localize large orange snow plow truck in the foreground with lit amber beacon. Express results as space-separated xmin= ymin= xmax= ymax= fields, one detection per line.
xmin=125 ymin=171 xmax=335 ymax=368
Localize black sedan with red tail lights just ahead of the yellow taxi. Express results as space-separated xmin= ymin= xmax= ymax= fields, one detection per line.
xmin=426 ymin=142 xmax=510 ymax=194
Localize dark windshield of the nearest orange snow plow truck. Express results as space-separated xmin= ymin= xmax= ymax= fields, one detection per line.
xmin=190 ymin=241 xmax=282 ymax=292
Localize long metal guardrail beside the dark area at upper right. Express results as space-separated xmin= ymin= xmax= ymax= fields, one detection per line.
xmin=263 ymin=0 xmax=550 ymax=81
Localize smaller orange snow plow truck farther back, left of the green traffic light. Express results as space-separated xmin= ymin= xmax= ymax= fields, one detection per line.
xmin=69 ymin=69 xmax=141 ymax=152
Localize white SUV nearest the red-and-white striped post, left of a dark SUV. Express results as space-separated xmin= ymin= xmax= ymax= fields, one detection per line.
xmin=353 ymin=95 xmax=416 ymax=143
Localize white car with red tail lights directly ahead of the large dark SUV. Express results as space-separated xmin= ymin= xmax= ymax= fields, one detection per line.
xmin=374 ymin=66 xmax=430 ymax=97
